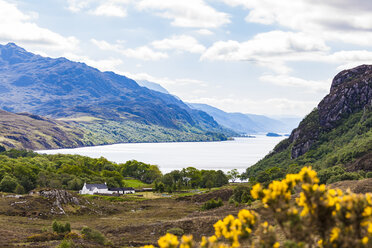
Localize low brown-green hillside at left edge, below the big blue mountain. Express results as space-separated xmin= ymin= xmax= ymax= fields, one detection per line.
xmin=0 ymin=110 xmax=94 ymax=150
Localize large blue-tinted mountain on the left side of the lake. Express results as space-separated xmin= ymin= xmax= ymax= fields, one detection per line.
xmin=0 ymin=43 xmax=232 ymax=145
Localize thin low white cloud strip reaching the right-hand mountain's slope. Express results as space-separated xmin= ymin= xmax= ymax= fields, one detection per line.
xmin=259 ymin=75 xmax=331 ymax=93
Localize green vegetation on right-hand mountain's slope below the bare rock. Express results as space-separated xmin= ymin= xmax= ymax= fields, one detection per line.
xmin=244 ymin=110 xmax=372 ymax=183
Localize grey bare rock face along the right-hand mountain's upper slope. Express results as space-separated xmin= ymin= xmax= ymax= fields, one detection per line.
xmin=287 ymin=65 xmax=372 ymax=159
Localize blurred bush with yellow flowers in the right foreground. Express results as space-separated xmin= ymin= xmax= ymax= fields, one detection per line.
xmin=145 ymin=167 xmax=372 ymax=248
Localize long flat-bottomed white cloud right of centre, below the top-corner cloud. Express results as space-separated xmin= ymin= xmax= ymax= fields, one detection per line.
xmin=201 ymin=31 xmax=329 ymax=73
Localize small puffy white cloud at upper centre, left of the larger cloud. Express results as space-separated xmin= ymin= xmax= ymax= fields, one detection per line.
xmin=151 ymin=35 xmax=205 ymax=53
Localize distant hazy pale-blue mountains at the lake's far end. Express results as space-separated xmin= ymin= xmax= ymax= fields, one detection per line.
xmin=188 ymin=103 xmax=298 ymax=134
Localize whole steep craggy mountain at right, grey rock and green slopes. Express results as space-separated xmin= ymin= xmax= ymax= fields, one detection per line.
xmin=246 ymin=65 xmax=372 ymax=183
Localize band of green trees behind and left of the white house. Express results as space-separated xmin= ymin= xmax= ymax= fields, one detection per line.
xmin=0 ymin=149 xmax=162 ymax=193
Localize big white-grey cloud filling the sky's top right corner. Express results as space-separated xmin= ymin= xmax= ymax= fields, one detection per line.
xmin=223 ymin=0 xmax=372 ymax=46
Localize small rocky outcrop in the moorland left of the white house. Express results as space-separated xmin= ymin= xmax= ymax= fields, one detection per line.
xmin=38 ymin=189 xmax=80 ymax=214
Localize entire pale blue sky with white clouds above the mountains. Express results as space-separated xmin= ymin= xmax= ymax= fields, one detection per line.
xmin=0 ymin=0 xmax=372 ymax=116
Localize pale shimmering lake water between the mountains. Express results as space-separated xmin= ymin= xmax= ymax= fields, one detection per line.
xmin=38 ymin=135 xmax=285 ymax=173
